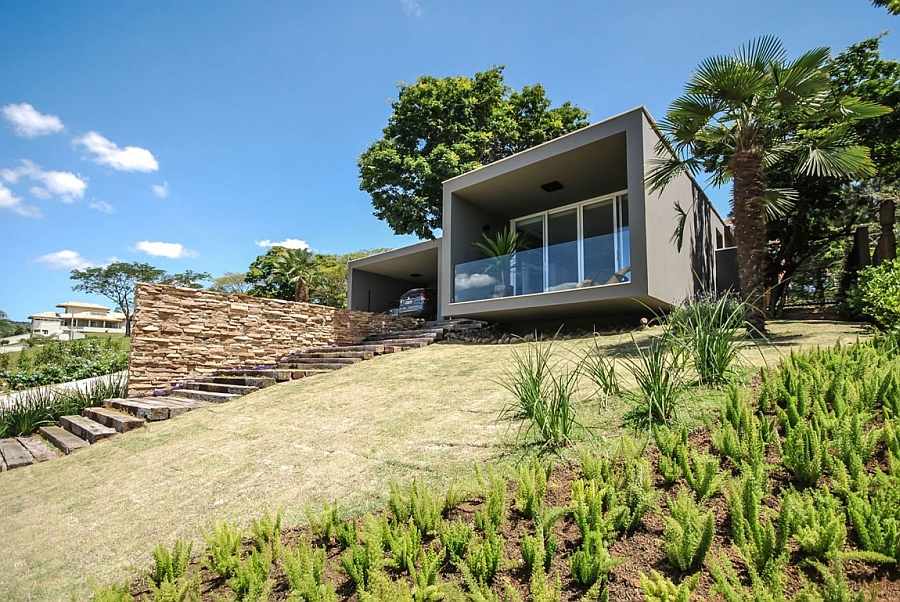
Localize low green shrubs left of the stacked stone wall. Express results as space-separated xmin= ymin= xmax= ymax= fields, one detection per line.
xmin=0 ymin=338 xmax=128 ymax=391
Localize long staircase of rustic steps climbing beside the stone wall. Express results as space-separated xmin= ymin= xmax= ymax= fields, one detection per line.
xmin=0 ymin=320 xmax=485 ymax=472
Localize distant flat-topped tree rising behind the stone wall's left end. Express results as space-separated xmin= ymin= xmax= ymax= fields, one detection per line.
xmin=69 ymin=261 xmax=210 ymax=335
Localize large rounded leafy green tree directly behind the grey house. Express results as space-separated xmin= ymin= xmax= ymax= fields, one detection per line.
xmin=358 ymin=66 xmax=588 ymax=238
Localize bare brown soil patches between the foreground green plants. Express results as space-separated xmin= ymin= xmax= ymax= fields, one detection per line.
xmin=131 ymin=429 xmax=900 ymax=602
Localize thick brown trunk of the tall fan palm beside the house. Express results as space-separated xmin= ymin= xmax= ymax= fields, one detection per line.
xmin=731 ymin=147 xmax=766 ymax=336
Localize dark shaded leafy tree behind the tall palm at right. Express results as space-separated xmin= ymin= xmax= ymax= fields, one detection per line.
xmin=766 ymin=38 xmax=900 ymax=315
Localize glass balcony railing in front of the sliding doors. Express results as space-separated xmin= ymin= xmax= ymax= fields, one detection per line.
xmin=453 ymin=234 xmax=631 ymax=303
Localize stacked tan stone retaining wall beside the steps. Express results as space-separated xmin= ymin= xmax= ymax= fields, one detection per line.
xmin=128 ymin=284 xmax=417 ymax=395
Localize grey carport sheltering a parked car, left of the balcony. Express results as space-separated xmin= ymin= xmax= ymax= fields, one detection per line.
xmin=347 ymin=239 xmax=441 ymax=312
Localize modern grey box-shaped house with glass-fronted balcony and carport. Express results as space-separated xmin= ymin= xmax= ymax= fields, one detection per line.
xmin=348 ymin=107 xmax=737 ymax=324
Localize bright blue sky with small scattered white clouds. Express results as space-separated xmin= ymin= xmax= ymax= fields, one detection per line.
xmin=0 ymin=0 xmax=900 ymax=320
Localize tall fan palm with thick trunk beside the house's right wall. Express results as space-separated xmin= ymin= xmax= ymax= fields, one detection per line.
xmin=645 ymin=36 xmax=889 ymax=334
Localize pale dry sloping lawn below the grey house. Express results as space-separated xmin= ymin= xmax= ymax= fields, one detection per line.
xmin=0 ymin=322 xmax=866 ymax=600
